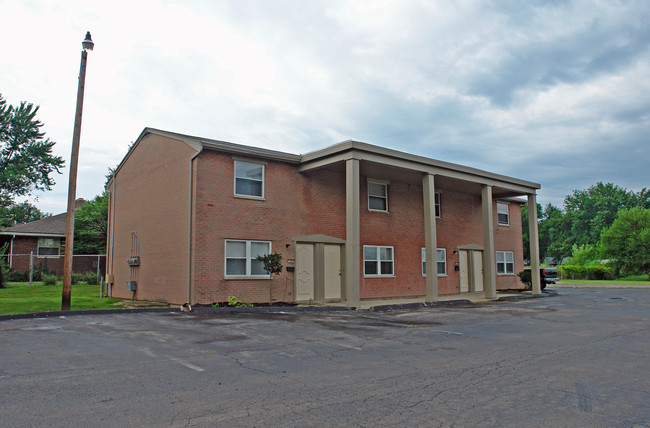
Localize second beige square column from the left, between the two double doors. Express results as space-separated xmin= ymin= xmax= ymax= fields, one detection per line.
xmin=422 ymin=174 xmax=438 ymax=302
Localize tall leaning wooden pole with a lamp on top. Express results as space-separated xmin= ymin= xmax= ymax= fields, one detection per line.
xmin=61 ymin=31 xmax=95 ymax=311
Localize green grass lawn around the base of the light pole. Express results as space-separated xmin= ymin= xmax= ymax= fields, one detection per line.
xmin=0 ymin=282 xmax=121 ymax=315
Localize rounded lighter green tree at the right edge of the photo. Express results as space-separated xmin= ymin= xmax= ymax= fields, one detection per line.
xmin=600 ymin=207 xmax=650 ymax=275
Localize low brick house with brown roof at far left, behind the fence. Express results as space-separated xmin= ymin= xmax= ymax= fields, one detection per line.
xmin=0 ymin=198 xmax=104 ymax=276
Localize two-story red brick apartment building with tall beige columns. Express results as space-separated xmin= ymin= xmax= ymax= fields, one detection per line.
xmin=106 ymin=128 xmax=540 ymax=307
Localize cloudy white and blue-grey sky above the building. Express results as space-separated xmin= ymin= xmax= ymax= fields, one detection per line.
xmin=0 ymin=0 xmax=650 ymax=213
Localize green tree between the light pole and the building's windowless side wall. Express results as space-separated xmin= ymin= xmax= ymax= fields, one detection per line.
xmin=74 ymin=192 xmax=108 ymax=254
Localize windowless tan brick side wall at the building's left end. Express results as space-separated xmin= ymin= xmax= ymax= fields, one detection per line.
xmin=107 ymin=135 xmax=196 ymax=303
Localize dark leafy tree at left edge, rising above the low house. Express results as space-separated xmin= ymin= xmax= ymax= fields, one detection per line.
xmin=0 ymin=94 xmax=64 ymax=206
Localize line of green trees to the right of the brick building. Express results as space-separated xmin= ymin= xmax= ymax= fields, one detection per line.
xmin=522 ymin=182 xmax=650 ymax=276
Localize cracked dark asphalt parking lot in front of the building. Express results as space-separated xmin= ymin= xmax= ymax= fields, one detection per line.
xmin=0 ymin=289 xmax=650 ymax=427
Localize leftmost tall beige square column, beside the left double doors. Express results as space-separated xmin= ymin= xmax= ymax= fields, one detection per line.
xmin=345 ymin=159 xmax=361 ymax=307
